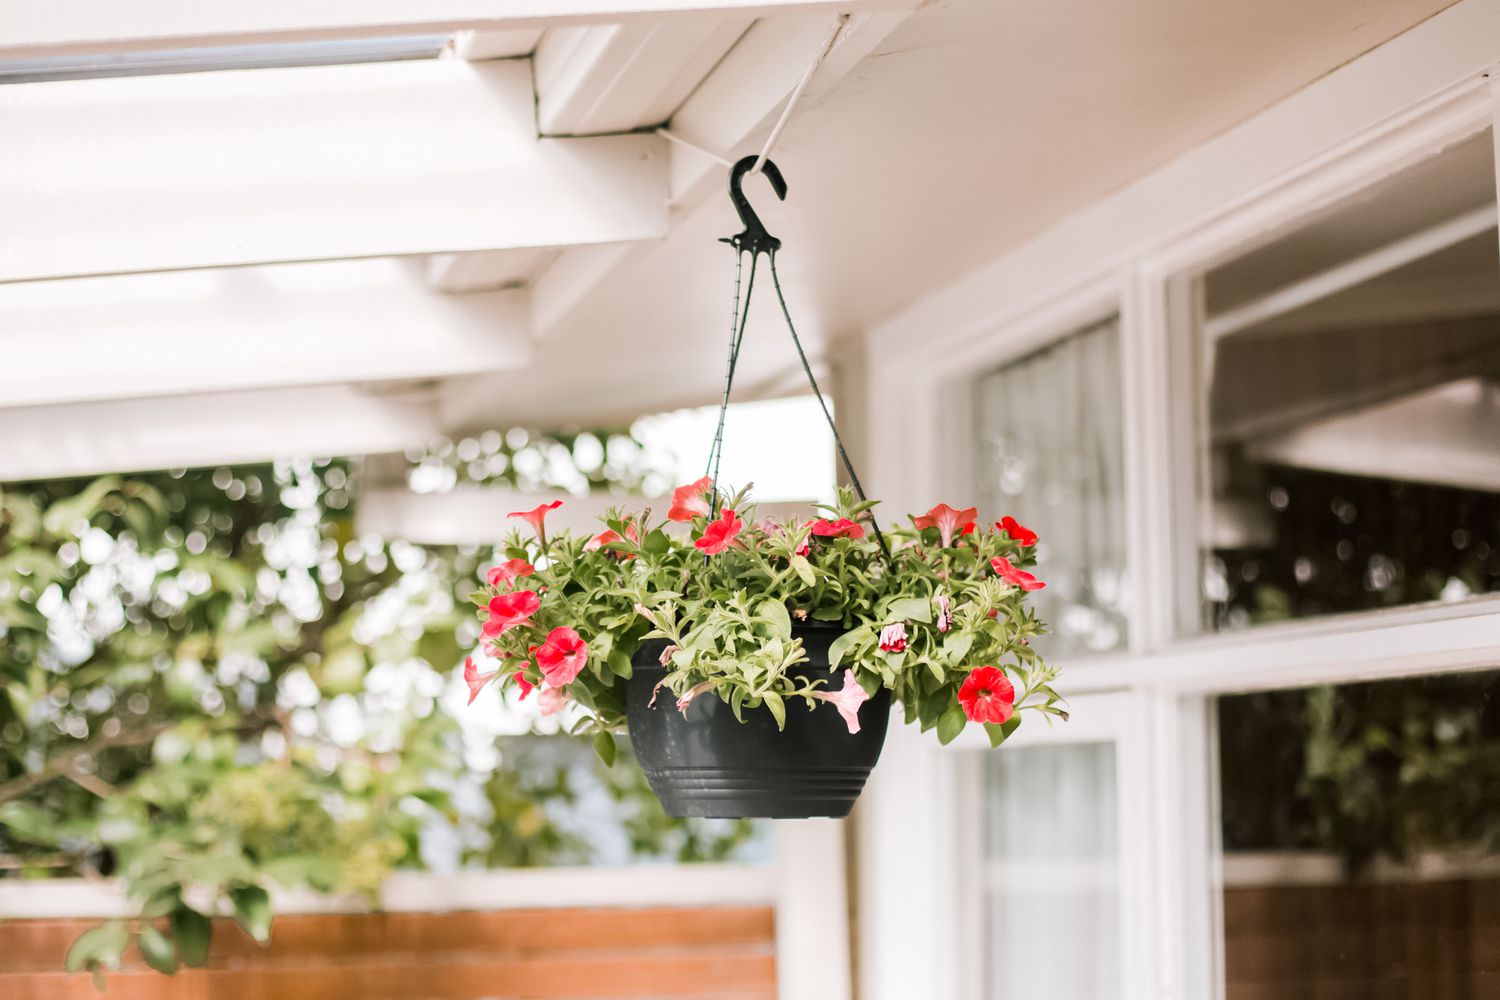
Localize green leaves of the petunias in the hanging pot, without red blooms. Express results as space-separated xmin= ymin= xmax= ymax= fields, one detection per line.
xmin=474 ymin=490 xmax=1065 ymax=742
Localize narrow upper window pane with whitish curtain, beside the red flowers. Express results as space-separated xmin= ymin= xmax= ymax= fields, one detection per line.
xmin=978 ymin=319 xmax=1127 ymax=655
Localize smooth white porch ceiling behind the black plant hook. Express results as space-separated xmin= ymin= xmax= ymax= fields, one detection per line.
xmin=447 ymin=0 xmax=1451 ymax=427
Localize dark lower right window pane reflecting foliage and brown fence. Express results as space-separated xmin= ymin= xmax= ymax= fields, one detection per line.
xmin=1218 ymin=672 xmax=1500 ymax=1000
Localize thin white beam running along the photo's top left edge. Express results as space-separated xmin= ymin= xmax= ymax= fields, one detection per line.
xmin=0 ymin=0 xmax=909 ymax=58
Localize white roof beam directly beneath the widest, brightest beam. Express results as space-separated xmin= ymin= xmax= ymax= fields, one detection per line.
xmin=0 ymin=259 xmax=531 ymax=406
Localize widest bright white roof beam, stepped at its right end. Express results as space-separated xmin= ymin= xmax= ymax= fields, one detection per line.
xmin=0 ymin=60 xmax=668 ymax=280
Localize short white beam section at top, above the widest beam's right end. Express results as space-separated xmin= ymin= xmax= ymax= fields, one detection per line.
xmin=534 ymin=18 xmax=750 ymax=135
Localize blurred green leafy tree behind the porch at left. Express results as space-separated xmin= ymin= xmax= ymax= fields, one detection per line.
xmin=0 ymin=435 xmax=749 ymax=973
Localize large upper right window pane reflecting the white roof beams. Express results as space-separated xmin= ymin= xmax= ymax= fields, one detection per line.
xmin=1200 ymin=133 xmax=1500 ymax=630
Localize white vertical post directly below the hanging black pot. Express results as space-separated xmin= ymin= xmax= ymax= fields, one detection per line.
xmin=776 ymin=820 xmax=852 ymax=1000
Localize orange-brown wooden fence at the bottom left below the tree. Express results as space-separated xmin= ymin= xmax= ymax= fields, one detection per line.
xmin=0 ymin=906 xmax=776 ymax=1000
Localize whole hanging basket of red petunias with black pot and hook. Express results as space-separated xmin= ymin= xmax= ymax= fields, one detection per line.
xmin=464 ymin=156 xmax=1065 ymax=819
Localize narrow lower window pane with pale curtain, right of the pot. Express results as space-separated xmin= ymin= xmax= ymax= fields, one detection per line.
xmin=984 ymin=744 xmax=1121 ymax=1000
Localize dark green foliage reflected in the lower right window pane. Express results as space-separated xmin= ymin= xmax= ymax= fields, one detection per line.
xmin=1220 ymin=672 xmax=1500 ymax=870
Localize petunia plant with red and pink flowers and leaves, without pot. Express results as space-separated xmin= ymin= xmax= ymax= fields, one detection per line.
xmin=464 ymin=477 xmax=1067 ymax=757
